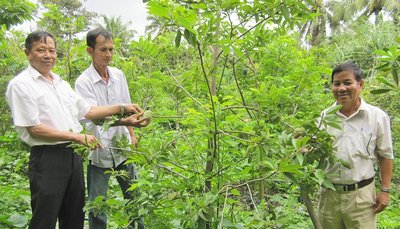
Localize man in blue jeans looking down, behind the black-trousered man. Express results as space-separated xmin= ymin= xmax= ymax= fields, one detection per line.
xmin=75 ymin=28 xmax=144 ymax=229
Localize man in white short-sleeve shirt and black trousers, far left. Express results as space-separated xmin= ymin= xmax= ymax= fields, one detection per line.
xmin=6 ymin=31 xmax=148 ymax=229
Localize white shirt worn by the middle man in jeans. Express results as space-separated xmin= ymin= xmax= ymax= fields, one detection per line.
xmin=75 ymin=64 xmax=131 ymax=168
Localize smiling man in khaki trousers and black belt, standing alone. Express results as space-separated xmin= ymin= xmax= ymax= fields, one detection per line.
xmin=319 ymin=62 xmax=394 ymax=229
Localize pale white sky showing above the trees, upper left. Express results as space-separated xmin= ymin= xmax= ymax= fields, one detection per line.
xmin=16 ymin=0 xmax=148 ymax=38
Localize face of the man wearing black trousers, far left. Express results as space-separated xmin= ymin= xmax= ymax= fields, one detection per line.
xmin=25 ymin=37 xmax=57 ymax=76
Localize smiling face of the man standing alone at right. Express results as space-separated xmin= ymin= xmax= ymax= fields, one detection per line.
xmin=332 ymin=71 xmax=364 ymax=106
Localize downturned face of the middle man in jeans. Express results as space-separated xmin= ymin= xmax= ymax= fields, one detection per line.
xmin=88 ymin=35 xmax=114 ymax=67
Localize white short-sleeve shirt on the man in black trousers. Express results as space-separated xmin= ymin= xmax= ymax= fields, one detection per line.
xmin=6 ymin=65 xmax=90 ymax=146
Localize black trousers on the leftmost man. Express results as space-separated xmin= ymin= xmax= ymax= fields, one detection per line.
xmin=29 ymin=143 xmax=85 ymax=229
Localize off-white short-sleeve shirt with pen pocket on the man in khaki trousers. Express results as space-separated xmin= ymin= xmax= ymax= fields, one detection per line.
xmin=323 ymin=99 xmax=394 ymax=184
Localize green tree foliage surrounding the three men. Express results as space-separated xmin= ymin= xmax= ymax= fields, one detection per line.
xmin=0 ymin=0 xmax=400 ymax=228
